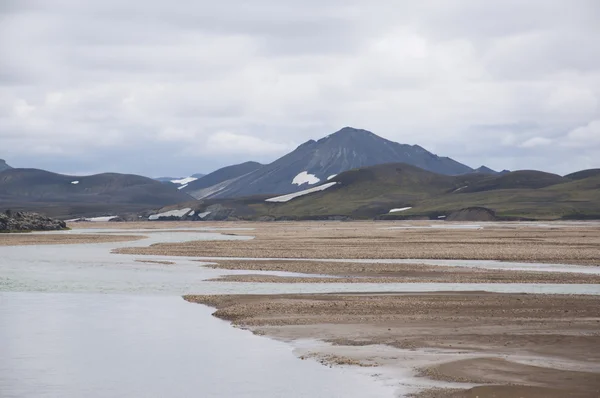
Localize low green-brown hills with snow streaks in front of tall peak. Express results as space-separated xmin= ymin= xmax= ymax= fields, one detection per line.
xmin=165 ymin=163 xmax=600 ymax=220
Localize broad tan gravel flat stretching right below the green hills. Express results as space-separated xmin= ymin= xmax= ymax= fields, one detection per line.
xmin=116 ymin=222 xmax=600 ymax=265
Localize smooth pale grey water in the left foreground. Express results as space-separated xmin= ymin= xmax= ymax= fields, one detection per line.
xmin=0 ymin=293 xmax=394 ymax=398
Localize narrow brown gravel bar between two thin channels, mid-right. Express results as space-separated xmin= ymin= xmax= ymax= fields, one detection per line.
xmin=207 ymin=260 xmax=600 ymax=284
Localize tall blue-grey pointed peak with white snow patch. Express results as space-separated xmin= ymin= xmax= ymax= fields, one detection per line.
xmin=209 ymin=127 xmax=473 ymax=198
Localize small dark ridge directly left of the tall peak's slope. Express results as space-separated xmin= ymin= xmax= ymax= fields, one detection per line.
xmin=183 ymin=162 xmax=263 ymax=199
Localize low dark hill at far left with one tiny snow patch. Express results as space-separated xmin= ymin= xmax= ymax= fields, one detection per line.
xmin=0 ymin=169 xmax=192 ymax=217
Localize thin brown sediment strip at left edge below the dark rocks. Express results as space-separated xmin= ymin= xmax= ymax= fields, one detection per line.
xmin=0 ymin=234 xmax=144 ymax=246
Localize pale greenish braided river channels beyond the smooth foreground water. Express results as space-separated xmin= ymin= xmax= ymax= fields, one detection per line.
xmin=0 ymin=229 xmax=600 ymax=295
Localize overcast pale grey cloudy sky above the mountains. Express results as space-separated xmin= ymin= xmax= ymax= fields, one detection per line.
xmin=0 ymin=0 xmax=600 ymax=177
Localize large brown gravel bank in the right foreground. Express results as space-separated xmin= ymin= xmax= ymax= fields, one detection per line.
xmin=185 ymin=292 xmax=600 ymax=398
